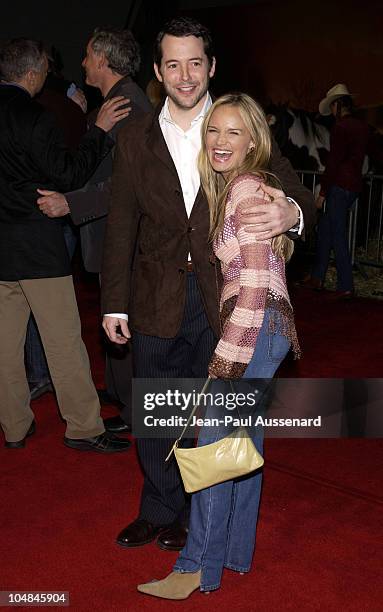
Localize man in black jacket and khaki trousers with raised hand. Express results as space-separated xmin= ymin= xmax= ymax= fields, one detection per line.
xmin=0 ymin=39 xmax=129 ymax=452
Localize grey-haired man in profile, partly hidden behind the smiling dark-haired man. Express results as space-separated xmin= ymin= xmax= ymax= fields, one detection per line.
xmin=38 ymin=28 xmax=152 ymax=433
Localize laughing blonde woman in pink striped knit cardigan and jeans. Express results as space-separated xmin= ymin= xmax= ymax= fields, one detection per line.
xmin=138 ymin=93 xmax=299 ymax=599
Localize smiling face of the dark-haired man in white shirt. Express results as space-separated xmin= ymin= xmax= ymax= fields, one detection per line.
xmin=154 ymin=34 xmax=215 ymax=110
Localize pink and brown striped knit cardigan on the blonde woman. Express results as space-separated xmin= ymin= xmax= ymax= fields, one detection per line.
xmin=209 ymin=174 xmax=300 ymax=378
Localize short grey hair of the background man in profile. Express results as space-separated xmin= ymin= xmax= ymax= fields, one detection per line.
xmin=91 ymin=27 xmax=141 ymax=76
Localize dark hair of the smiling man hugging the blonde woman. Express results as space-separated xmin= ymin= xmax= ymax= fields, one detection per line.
xmin=154 ymin=17 xmax=214 ymax=67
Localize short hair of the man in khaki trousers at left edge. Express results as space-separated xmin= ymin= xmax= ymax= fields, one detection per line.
xmin=0 ymin=38 xmax=47 ymax=81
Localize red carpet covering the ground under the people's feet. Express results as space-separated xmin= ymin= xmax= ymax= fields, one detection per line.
xmin=0 ymin=274 xmax=383 ymax=612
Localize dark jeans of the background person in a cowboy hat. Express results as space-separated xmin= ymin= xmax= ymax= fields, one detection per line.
xmin=312 ymin=185 xmax=358 ymax=291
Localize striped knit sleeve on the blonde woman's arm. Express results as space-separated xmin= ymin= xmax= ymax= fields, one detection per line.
xmin=209 ymin=176 xmax=271 ymax=378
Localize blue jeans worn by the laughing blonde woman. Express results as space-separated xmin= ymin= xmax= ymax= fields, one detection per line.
xmin=174 ymin=311 xmax=290 ymax=591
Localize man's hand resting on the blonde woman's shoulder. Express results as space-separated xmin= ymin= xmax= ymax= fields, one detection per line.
xmin=241 ymin=184 xmax=299 ymax=240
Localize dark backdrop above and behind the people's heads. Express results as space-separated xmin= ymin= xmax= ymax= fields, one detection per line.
xmin=0 ymin=0 xmax=383 ymax=116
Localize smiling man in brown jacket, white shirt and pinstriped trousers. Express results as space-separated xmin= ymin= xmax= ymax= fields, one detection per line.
xmin=102 ymin=18 xmax=315 ymax=550
